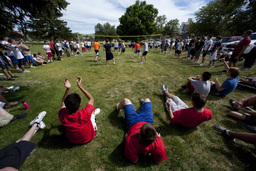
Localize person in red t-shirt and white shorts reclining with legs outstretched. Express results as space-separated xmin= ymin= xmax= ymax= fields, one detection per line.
xmin=161 ymin=85 xmax=212 ymax=128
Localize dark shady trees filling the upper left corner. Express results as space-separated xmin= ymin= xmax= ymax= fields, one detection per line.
xmin=0 ymin=0 xmax=75 ymax=39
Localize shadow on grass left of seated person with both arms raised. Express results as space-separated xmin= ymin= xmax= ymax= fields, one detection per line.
xmin=37 ymin=125 xmax=77 ymax=149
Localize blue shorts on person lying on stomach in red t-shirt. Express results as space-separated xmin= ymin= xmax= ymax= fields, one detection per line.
xmin=124 ymin=102 xmax=153 ymax=129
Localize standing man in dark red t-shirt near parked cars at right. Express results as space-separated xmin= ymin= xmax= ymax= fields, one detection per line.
xmin=228 ymin=30 xmax=252 ymax=67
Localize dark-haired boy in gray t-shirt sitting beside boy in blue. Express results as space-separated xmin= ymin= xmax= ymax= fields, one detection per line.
xmin=182 ymin=72 xmax=211 ymax=97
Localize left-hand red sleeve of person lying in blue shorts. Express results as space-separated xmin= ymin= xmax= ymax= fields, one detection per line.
xmin=124 ymin=136 xmax=138 ymax=163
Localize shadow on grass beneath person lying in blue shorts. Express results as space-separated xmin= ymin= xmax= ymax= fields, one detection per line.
xmin=108 ymin=140 xmax=160 ymax=168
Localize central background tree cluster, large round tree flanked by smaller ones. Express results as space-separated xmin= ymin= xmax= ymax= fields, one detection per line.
xmin=95 ymin=0 xmax=179 ymax=39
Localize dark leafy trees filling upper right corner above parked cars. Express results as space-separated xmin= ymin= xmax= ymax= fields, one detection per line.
xmin=189 ymin=0 xmax=256 ymax=36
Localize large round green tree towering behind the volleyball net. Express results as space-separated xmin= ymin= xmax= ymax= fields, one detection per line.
xmin=117 ymin=0 xmax=158 ymax=35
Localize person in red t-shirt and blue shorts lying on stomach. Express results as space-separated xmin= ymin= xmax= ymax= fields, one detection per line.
xmin=117 ymin=98 xmax=167 ymax=163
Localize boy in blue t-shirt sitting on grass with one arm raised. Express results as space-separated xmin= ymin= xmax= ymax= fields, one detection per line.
xmin=210 ymin=58 xmax=240 ymax=96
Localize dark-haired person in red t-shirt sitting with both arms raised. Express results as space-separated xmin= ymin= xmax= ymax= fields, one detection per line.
xmin=59 ymin=77 xmax=100 ymax=144
